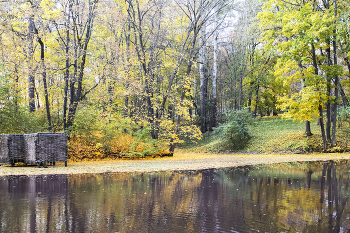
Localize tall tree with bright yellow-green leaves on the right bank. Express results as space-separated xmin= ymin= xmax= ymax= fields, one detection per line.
xmin=260 ymin=1 xmax=342 ymax=148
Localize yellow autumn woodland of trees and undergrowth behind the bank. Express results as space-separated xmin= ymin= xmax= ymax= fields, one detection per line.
xmin=0 ymin=0 xmax=350 ymax=157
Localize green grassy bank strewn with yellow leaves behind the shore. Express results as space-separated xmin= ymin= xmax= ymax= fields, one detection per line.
xmin=182 ymin=117 xmax=350 ymax=154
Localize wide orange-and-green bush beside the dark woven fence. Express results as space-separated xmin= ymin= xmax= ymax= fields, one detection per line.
xmin=69 ymin=106 xmax=169 ymax=160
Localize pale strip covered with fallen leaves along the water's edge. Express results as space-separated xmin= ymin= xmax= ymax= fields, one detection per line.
xmin=0 ymin=151 xmax=350 ymax=176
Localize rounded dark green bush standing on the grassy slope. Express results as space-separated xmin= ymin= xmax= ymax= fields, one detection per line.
xmin=214 ymin=110 xmax=253 ymax=150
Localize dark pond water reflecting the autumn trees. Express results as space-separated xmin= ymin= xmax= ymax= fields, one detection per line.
xmin=0 ymin=161 xmax=350 ymax=233
